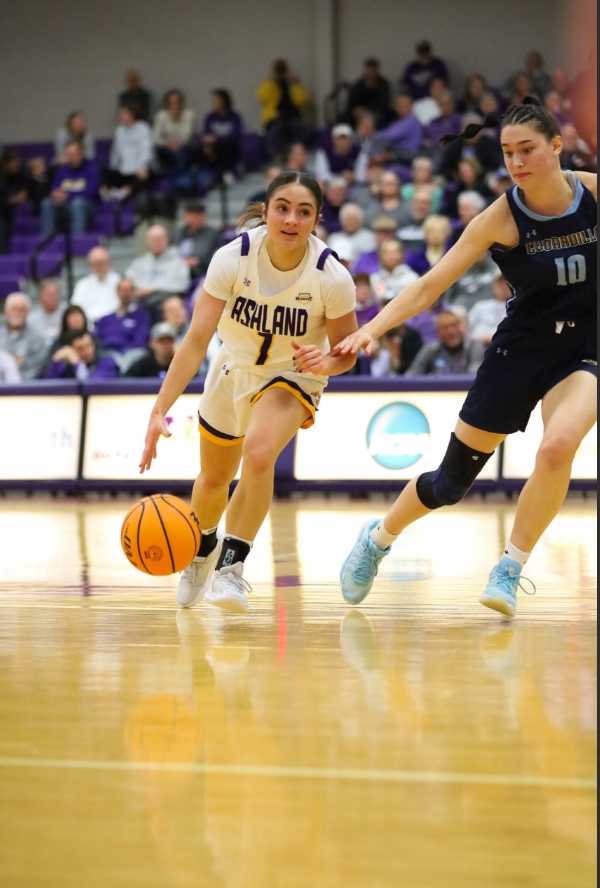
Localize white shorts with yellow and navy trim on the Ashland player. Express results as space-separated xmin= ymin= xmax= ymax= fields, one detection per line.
xmin=198 ymin=355 xmax=325 ymax=447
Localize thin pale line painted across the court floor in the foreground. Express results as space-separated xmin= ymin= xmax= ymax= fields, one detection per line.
xmin=0 ymin=757 xmax=597 ymax=790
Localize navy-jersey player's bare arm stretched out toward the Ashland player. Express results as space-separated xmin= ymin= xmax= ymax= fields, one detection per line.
xmin=333 ymin=198 xmax=516 ymax=355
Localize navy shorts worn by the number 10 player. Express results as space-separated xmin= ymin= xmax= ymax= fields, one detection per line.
xmin=460 ymin=318 xmax=598 ymax=435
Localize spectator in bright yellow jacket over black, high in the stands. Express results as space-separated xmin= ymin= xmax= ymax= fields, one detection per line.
xmin=256 ymin=59 xmax=310 ymax=156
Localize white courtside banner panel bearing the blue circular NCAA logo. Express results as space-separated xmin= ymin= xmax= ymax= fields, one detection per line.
xmin=295 ymin=392 xmax=498 ymax=481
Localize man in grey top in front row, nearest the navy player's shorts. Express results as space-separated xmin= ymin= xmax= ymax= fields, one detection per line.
xmin=407 ymin=311 xmax=484 ymax=376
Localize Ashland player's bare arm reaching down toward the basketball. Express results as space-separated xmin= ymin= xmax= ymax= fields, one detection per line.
xmin=140 ymin=289 xmax=226 ymax=475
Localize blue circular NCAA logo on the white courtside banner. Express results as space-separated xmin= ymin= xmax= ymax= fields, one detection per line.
xmin=367 ymin=401 xmax=431 ymax=469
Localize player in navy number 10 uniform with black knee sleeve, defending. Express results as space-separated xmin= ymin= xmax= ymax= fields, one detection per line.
xmin=336 ymin=97 xmax=598 ymax=617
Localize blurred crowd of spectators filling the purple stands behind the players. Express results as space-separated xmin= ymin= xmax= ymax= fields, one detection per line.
xmin=0 ymin=41 xmax=596 ymax=382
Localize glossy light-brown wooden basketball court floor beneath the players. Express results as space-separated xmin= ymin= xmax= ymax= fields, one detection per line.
xmin=0 ymin=497 xmax=596 ymax=888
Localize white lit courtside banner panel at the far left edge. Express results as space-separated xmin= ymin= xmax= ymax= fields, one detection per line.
xmin=0 ymin=395 xmax=83 ymax=481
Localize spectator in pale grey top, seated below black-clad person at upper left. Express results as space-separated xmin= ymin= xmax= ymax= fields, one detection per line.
xmin=104 ymin=105 xmax=152 ymax=198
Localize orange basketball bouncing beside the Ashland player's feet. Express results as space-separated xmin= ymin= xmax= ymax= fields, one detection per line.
xmin=121 ymin=493 xmax=201 ymax=577
